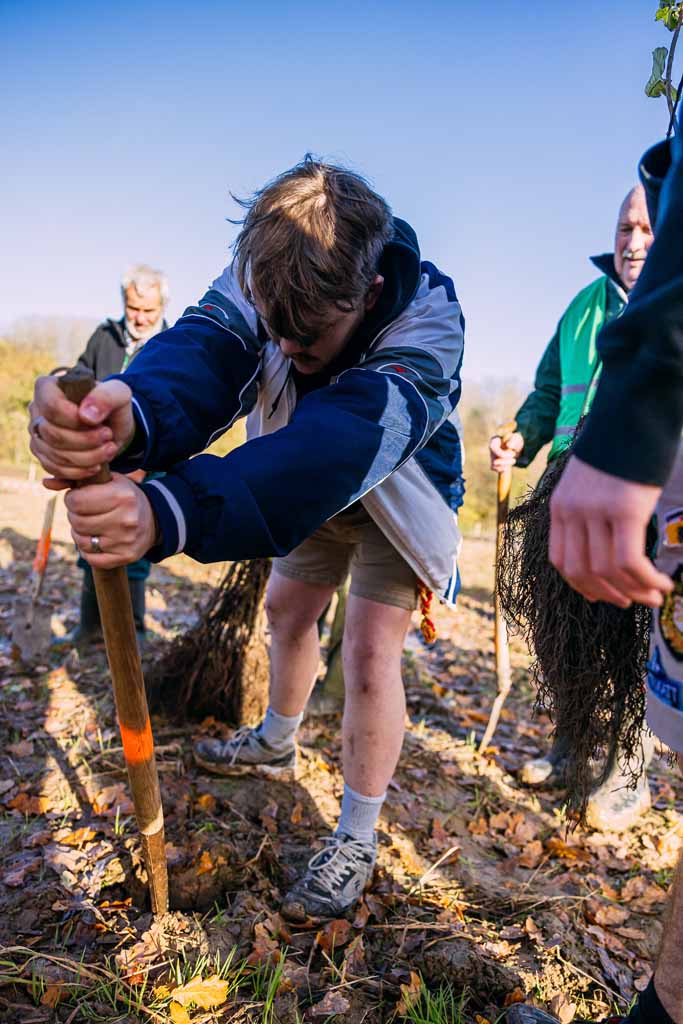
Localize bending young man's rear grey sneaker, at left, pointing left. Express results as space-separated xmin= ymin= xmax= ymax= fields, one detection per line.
xmin=193 ymin=725 xmax=296 ymax=778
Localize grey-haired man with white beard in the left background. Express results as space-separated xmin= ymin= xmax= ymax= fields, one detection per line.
xmin=58 ymin=263 xmax=169 ymax=646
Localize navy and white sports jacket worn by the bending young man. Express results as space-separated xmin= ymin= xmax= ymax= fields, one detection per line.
xmin=113 ymin=220 xmax=465 ymax=603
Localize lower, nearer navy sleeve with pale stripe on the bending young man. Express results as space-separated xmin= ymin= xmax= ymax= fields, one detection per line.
xmin=142 ymin=368 xmax=429 ymax=562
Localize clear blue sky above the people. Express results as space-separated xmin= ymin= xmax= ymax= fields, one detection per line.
xmin=0 ymin=0 xmax=670 ymax=380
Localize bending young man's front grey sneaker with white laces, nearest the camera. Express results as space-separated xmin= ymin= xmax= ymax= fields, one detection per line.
xmin=281 ymin=833 xmax=377 ymax=923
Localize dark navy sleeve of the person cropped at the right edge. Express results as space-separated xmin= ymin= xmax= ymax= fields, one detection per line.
xmin=575 ymin=120 xmax=683 ymax=485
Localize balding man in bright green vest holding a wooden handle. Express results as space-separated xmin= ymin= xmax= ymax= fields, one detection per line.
xmin=489 ymin=185 xmax=653 ymax=830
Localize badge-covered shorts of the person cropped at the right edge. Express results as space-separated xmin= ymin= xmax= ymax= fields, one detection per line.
xmin=647 ymin=446 xmax=683 ymax=754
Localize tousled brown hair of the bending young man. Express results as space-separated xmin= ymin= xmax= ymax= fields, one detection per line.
xmin=234 ymin=155 xmax=393 ymax=345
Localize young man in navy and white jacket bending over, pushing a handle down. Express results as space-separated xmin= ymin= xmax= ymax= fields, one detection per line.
xmin=26 ymin=158 xmax=464 ymax=920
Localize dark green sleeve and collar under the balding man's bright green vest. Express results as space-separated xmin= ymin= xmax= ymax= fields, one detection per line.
xmin=515 ymin=253 xmax=626 ymax=468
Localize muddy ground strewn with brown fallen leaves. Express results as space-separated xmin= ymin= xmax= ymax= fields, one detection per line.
xmin=0 ymin=480 xmax=683 ymax=1024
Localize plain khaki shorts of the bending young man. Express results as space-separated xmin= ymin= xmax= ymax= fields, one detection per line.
xmin=272 ymin=502 xmax=418 ymax=611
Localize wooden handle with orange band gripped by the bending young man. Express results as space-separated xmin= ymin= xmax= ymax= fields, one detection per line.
xmin=57 ymin=370 xmax=168 ymax=913
